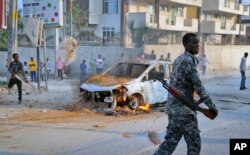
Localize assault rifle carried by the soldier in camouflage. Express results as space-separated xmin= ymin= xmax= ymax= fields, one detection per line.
xmin=155 ymin=77 xmax=216 ymax=120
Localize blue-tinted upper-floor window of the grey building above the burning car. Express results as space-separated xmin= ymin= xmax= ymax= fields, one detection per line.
xmin=103 ymin=0 xmax=118 ymax=14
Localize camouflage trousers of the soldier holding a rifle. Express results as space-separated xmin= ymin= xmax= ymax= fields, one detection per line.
xmin=154 ymin=114 xmax=201 ymax=155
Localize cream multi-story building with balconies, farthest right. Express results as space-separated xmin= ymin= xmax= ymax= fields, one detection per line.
xmin=201 ymin=0 xmax=249 ymax=44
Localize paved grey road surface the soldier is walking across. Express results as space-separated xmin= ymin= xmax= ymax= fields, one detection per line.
xmin=0 ymin=77 xmax=250 ymax=155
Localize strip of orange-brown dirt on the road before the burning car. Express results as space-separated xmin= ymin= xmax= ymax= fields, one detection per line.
xmin=0 ymin=109 xmax=164 ymax=125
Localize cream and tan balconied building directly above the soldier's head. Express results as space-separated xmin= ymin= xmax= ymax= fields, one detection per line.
xmin=127 ymin=0 xmax=202 ymax=44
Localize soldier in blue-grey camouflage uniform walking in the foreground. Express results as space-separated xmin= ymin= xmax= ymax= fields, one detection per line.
xmin=155 ymin=33 xmax=218 ymax=155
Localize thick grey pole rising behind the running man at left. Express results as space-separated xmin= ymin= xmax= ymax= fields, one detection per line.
xmin=8 ymin=0 xmax=18 ymax=65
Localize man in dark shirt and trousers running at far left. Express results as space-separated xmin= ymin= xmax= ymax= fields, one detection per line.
xmin=8 ymin=53 xmax=27 ymax=104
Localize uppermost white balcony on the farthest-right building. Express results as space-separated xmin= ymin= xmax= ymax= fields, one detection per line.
xmin=202 ymin=0 xmax=249 ymax=16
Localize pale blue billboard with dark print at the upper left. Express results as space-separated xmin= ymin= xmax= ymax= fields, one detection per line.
xmin=23 ymin=0 xmax=63 ymax=27
